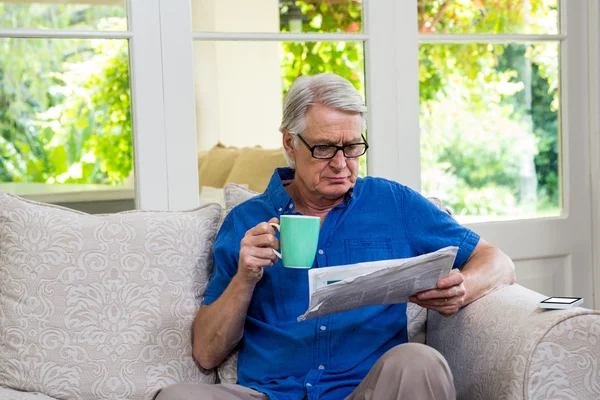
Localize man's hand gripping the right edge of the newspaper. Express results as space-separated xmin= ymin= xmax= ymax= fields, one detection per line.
xmin=410 ymin=270 xmax=467 ymax=317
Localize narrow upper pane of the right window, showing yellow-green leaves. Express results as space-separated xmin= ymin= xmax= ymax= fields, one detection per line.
xmin=418 ymin=0 xmax=559 ymax=34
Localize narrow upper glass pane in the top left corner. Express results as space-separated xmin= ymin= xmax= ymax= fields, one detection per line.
xmin=0 ymin=0 xmax=127 ymax=31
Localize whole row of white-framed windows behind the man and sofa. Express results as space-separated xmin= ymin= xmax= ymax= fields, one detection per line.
xmin=0 ymin=0 xmax=582 ymax=216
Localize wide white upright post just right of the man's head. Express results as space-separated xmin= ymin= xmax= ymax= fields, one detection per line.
xmin=365 ymin=0 xmax=421 ymax=190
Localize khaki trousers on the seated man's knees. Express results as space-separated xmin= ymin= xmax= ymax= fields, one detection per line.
xmin=156 ymin=343 xmax=456 ymax=400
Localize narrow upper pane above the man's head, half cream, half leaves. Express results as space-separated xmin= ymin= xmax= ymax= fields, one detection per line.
xmin=192 ymin=0 xmax=362 ymax=33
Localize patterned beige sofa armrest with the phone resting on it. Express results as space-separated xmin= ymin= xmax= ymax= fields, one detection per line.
xmin=427 ymin=285 xmax=600 ymax=400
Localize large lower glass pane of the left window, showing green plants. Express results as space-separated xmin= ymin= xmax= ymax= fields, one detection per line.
xmin=0 ymin=38 xmax=133 ymax=212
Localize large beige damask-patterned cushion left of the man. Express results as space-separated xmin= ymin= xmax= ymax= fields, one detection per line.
xmin=0 ymin=193 xmax=221 ymax=399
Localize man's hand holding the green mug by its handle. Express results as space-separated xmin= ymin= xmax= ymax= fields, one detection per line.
xmin=237 ymin=218 xmax=279 ymax=284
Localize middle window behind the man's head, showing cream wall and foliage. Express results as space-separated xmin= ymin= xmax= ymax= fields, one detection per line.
xmin=192 ymin=0 xmax=367 ymax=197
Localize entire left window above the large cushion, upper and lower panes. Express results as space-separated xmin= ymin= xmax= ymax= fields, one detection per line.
xmin=0 ymin=1 xmax=134 ymax=212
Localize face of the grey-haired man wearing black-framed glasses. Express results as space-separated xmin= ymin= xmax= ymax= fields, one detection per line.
xmin=284 ymin=105 xmax=363 ymax=199
